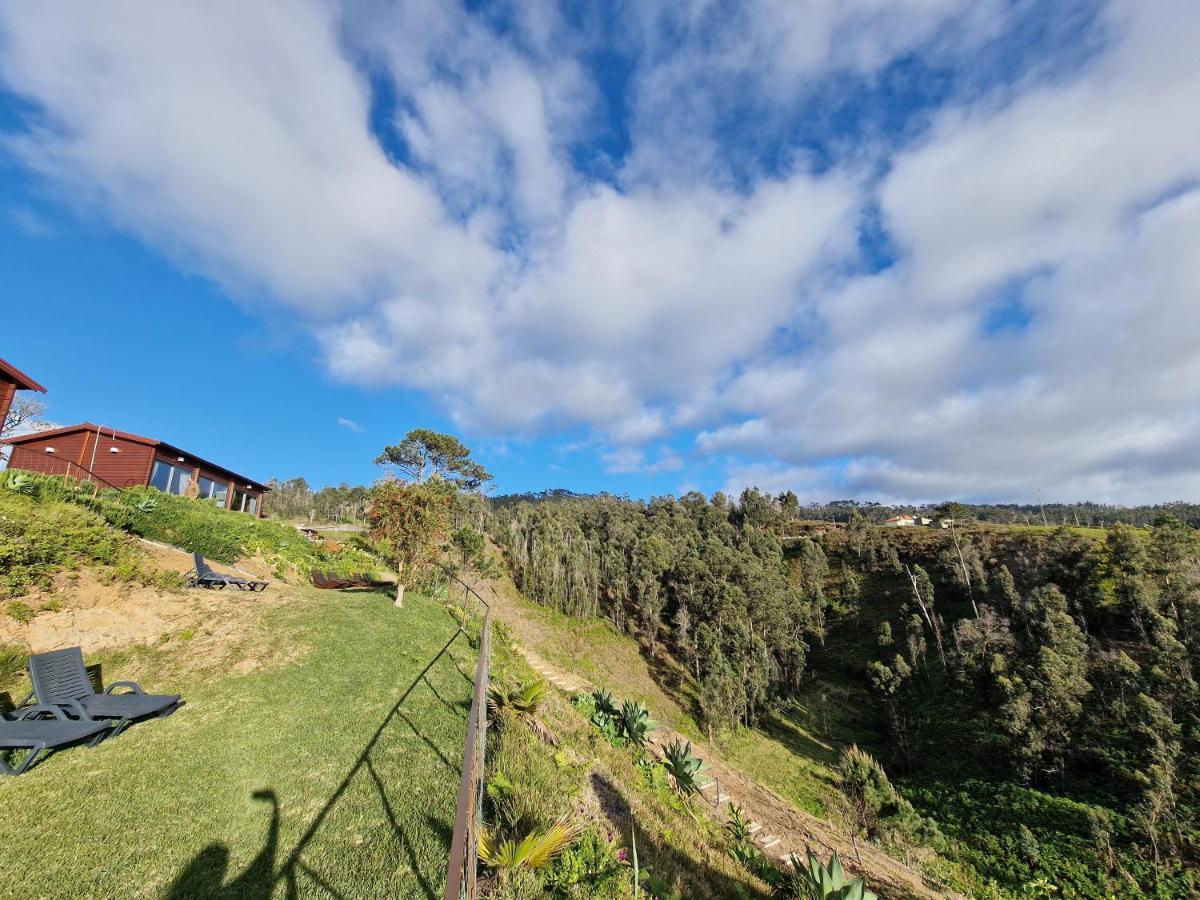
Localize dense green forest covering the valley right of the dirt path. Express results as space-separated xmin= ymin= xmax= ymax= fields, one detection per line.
xmin=487 ymin=491 xmax=1200 ymax=898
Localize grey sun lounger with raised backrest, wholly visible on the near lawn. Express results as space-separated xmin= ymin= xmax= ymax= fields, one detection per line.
xmin=25 ymin=647 xmax=182 ymax=734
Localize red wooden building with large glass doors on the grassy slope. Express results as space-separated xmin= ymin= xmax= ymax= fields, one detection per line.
xmin=5 ymin=422 xmax=270 ymax=516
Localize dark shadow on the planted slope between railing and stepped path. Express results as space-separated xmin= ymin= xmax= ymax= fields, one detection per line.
xmin=592 ymin=772 xmax=766 ymax=899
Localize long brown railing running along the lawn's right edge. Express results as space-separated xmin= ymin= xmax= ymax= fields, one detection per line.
xmin=445 ymin=569 xmax=492 ymax=900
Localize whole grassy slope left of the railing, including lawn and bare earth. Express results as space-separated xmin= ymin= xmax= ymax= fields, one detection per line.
xmin=0 ymin=481 xmax=475 ymax=898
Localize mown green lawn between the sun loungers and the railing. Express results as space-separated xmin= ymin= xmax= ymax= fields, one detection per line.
xmin=0 ymin=589 xmax=475 ymax=898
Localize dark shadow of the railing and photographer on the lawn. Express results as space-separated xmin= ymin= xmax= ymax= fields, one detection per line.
xmin=167 ymin=630 xmax=466 ymax=900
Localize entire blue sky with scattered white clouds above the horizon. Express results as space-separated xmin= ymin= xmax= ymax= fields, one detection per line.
xmin=0 ymin=0 xmax=1200 ymax=503
